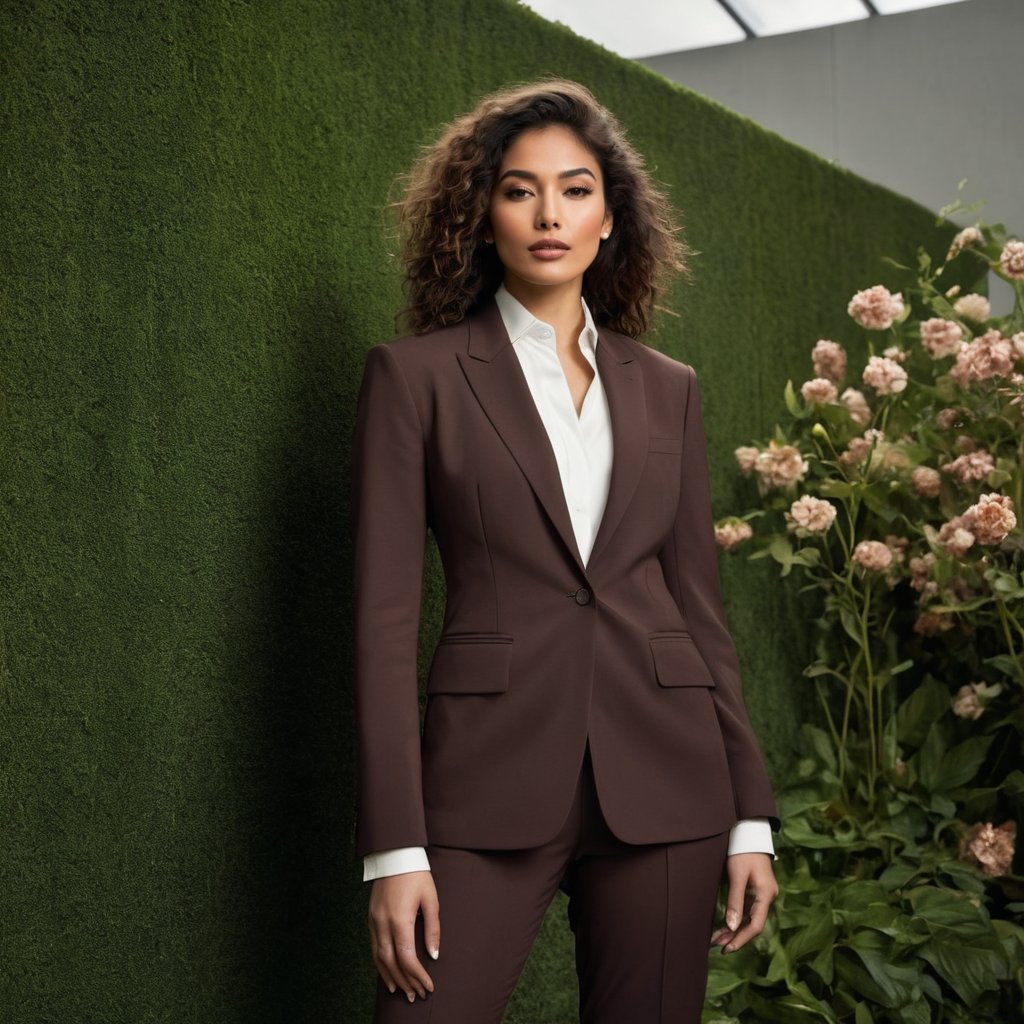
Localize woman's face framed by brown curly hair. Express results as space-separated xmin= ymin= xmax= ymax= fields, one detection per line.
xmin=487 ymin=125 xmax=611 ymax=297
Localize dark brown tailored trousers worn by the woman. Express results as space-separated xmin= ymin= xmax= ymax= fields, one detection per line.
xmin=374 ymin=752 xmax=728 ymax=1024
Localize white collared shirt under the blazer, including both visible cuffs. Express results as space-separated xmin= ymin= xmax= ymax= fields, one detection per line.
xmin=362 ymin=285 xmax=774 ymax=882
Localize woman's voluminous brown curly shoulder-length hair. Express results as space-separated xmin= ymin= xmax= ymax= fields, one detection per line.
xmin=395 ymin=79 xmax=688 ymax=337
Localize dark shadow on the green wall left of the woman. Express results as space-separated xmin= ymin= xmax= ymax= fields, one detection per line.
xmin=230 ymin=292 xmax=373 ymax=1024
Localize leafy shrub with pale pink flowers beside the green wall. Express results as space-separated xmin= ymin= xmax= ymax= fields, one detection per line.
xmin=705 ymin=218 xmax=1024 ymax=1024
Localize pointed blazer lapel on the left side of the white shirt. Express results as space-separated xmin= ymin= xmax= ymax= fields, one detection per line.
xmin=458 ymin=302 xmax=585 ymax=572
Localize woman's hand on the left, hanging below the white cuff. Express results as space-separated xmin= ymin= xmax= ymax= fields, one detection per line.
xmin=370 ymin=871 xmax=441 ymax=1002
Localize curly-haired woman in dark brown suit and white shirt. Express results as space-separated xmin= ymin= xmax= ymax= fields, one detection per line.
xmin=354 ymin=81 xmax=776 ymax=1024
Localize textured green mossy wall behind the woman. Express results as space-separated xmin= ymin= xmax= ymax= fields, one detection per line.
xmin=0 ymin=0 xmax=950 ymax=1024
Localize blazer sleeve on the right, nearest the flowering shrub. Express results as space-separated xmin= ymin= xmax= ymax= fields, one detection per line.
xmin=658 ymin=367 xmax=778 ymax=828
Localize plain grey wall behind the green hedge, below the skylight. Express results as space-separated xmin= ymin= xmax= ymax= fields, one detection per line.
xmin=643 ymin=0 xmax=1024 ymax=276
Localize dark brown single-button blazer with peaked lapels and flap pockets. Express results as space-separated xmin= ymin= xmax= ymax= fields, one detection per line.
xmin=353 ymin=302 xmax=775 ymax=854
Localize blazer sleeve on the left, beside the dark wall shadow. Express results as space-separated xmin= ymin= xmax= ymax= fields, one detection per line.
xmin=352 ymin=345 xmax=427 ymax=856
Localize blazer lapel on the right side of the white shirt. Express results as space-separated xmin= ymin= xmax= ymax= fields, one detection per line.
xmin=588 ymin=330 xmax=648 ymax=566
